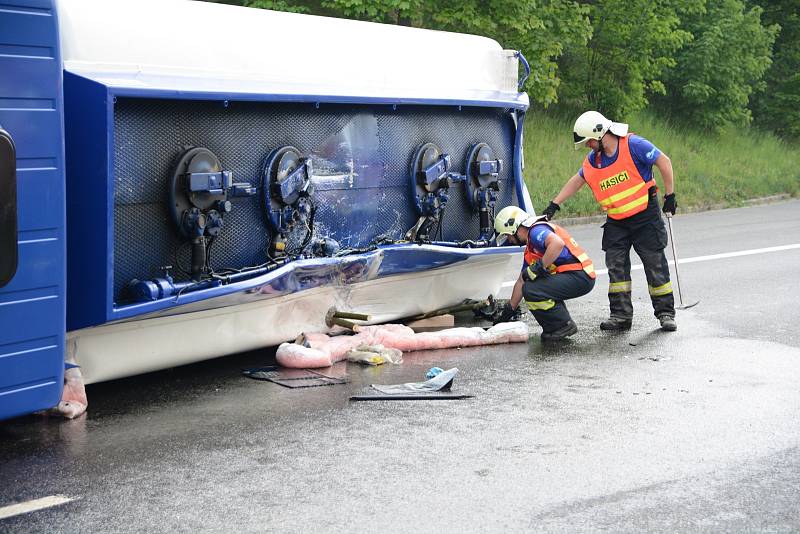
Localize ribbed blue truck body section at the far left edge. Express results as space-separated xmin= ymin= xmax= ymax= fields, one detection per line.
xmin=0 ymin=0 xmax=66 ymax=419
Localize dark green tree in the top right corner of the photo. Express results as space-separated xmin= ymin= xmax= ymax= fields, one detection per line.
xmin=752 ymin=0 xmax=800 ymax=139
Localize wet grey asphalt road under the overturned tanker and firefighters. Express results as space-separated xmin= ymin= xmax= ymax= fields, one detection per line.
xmin=0 ymin=201 xmax=800 ymax=533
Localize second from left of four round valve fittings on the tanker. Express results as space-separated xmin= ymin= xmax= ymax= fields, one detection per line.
xmin=261 ymin=146 xmax=315 ymax=254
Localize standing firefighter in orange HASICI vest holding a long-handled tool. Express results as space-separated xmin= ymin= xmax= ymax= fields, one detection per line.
xmin=543 ymin=111 xmax=678 ymax=331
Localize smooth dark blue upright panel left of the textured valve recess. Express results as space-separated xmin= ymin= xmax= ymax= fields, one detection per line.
xmin=64 ymin=72 xmax=114 ymax=331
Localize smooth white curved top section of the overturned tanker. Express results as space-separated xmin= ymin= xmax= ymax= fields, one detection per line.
xmin=57 ymin=0 xmax=528 ymax=107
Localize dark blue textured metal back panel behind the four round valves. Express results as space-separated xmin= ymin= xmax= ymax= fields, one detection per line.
xmin=113 ymin=98 xmax=515 ymax=295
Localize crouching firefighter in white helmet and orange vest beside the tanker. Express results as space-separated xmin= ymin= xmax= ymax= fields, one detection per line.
xmin=494 ymin=206 xmax=595 ymax=341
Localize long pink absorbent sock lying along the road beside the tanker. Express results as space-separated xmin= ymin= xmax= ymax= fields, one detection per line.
xmin=276 ymin=322 xmax=528 ymax=369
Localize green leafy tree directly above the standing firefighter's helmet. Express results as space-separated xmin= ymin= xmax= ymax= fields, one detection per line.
xmin=561 ymin=0 xmax=700 ymax=119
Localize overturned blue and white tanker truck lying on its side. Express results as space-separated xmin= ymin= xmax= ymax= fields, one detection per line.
xmin=0 ymin=0 xmax=532 ymax=418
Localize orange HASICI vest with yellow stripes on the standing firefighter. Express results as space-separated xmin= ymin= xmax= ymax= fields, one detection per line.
xmin=583 ymin=134 xmax=656 ymax=220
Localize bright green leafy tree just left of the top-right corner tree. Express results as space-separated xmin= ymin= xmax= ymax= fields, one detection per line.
xmin=665 ymin=0 xmax=777 ymax=131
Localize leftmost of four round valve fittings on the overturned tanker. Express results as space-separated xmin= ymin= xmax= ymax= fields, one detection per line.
xmin=169 ymin=147 xmax=256 ymax=280
